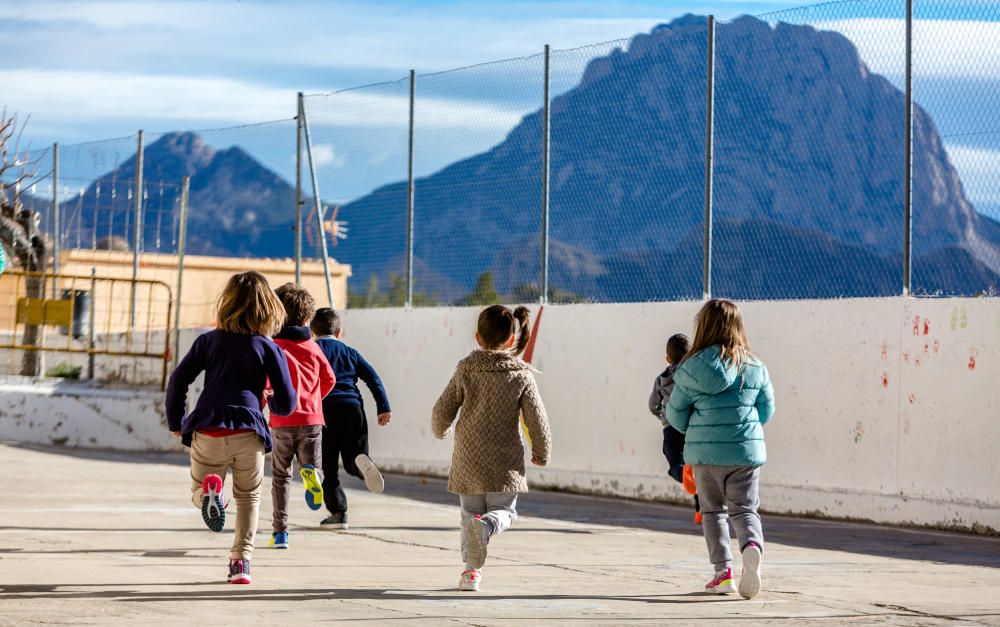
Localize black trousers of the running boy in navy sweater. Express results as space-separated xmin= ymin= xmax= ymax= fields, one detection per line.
xmin=323 ymin=403 xmax=368 ymax=514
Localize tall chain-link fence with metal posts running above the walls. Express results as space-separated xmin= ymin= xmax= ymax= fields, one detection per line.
xmin=3 ymin=0 xmax=1000 ymax=307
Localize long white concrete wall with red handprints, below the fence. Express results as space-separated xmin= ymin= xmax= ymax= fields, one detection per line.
xmin=336 ymin=298 xmax=1000 ymax=530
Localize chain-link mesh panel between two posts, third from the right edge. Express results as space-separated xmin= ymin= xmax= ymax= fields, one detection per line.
xmin=550 ymin=30 xmax=708 ymax=302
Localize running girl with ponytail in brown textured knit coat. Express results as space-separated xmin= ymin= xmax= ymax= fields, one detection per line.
xmin=432 ymin=305 xmax=552 ymax=591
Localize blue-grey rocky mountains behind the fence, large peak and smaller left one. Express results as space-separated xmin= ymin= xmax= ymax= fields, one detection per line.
xmin=56 ymin=15 xmax=1000 ymax=302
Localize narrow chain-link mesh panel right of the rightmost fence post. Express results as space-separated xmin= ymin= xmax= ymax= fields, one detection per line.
xmin=913 ymin=0 xmax=1000 ymax=296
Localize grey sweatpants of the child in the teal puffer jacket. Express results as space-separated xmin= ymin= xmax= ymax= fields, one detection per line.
xmin=694 ymin=464 xmax=764 ymax=572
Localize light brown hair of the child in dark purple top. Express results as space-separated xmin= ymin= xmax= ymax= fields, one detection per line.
xmin=216 ymin=270 xmax=285 ymax=335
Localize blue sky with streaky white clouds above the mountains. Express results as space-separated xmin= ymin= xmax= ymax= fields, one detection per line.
xmin=0 ymin=0 xmax=1000 ymax=213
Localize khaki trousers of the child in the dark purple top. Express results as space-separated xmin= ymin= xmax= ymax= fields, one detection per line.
xmin=191 ymin=432 xmax=264 ymax=560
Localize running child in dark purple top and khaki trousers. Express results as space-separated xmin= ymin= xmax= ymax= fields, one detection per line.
xmin=166 ymin=272 xmax=298 ymax=583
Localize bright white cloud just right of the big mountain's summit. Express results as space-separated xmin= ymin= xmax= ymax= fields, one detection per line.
xmin=813 ymin=18 xmax=1000 ymax=80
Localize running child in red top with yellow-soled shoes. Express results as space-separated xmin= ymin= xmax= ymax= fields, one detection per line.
xmin=271 ymin=283 xmax=336 ymax=549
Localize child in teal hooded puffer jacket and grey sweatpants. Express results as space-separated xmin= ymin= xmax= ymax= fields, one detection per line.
xmin=666 ymin=300 xmax=774 ymax=599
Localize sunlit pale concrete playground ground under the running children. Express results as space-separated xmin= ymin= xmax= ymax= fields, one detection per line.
xmin=0 ymin=444 xmax=1000 ymax=627
